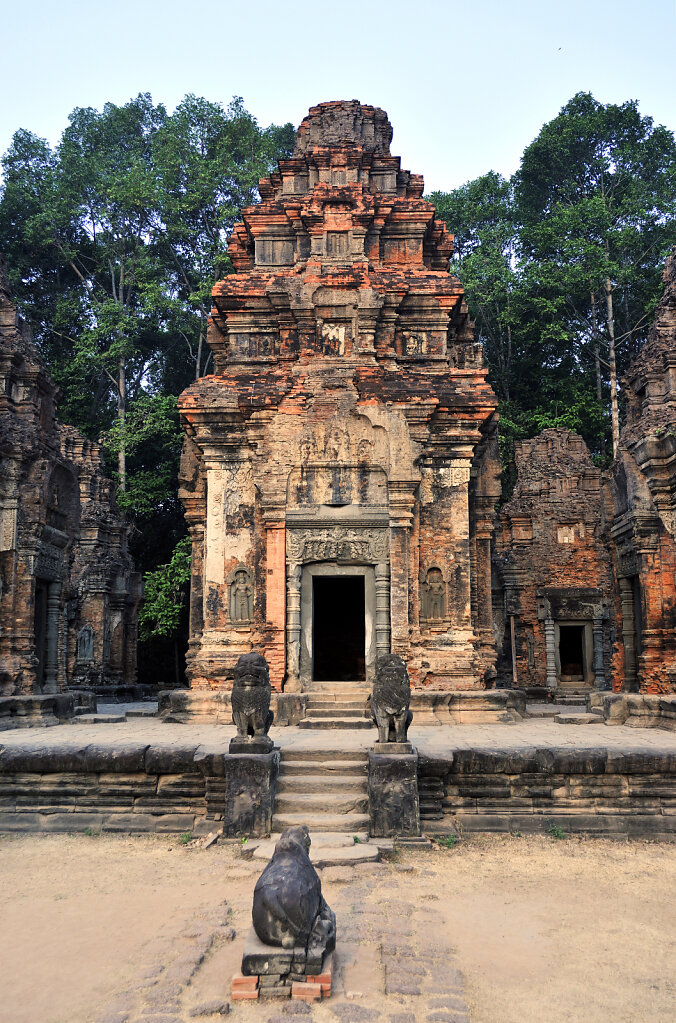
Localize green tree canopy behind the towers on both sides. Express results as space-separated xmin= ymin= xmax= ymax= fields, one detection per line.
xmin=0 ymin=93 xmax=676 ymax=671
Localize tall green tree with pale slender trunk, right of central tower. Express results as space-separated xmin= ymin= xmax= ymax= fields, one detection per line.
xmin=516 ymin=92 xmax=676 ymax=453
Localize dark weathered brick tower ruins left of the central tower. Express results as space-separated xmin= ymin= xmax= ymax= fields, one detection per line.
xmin=0 ymin=263 xmax=141 ymax=696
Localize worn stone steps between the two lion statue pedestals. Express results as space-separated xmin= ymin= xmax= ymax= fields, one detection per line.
xmin=272 ymin=750 xmax=368 ymax=835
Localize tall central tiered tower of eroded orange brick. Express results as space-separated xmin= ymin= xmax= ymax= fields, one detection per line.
xmin=180 ymin=101 xmax=499 ymax=688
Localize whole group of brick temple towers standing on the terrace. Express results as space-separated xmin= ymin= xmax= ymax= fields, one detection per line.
xmin=0 ymin=100 xmax=676 ymax=746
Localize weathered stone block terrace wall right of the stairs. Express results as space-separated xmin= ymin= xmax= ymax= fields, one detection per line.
xmin=418 ymin=745 xmax=676 ymax=840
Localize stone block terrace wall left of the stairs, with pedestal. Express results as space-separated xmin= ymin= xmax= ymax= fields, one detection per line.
xmin=0 ymin=742 xmax=279 ymax=837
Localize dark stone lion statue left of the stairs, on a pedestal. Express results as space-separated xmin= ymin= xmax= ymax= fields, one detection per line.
xmin=230 ymin=651 xmax=274 ymax=753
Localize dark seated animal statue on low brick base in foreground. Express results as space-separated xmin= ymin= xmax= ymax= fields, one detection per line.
xmin=252 ymin=825 xmax=335 ymax=953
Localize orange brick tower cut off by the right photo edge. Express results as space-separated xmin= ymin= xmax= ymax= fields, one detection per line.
xmin=612 ymin=250 xmax=676 ymax=693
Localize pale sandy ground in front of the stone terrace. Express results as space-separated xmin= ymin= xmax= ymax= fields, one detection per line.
xmin=0 ymin=835 xmax=676 ymax=1023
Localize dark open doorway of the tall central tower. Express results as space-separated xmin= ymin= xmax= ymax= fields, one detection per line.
xmin=312 ymin=576 xmax=366 ymax=682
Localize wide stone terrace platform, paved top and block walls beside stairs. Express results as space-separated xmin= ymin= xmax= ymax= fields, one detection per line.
xmin=0 ymin=718 xmax=676 ymax=838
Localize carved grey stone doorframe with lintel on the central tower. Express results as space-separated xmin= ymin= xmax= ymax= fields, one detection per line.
xmin=284 ymin=525 xmax=391 ymax=691
